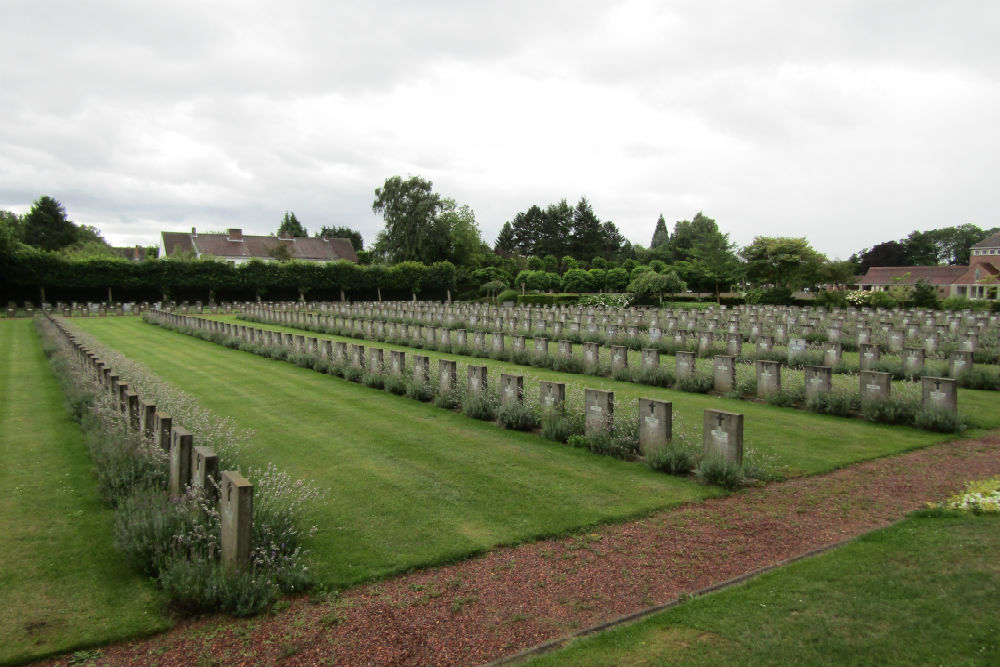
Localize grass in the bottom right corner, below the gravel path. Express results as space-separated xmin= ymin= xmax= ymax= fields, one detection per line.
xmin=522 ymin=516 xmax=1000 ymax=667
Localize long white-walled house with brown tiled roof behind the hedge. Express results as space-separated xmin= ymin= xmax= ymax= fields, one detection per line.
xmin=160 ymin=227 xmax=358 ymax=265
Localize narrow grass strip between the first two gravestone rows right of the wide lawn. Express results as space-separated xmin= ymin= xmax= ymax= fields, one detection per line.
xmin=201 ymin=316 xmax=984 ymax=475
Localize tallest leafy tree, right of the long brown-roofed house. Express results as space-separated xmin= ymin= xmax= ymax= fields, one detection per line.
xmin=372 ymin=176 xmax=451 ymax=264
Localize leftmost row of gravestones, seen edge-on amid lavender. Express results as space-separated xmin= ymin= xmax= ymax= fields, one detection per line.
xmin=52 ymin=312 xmax=254 ymax=568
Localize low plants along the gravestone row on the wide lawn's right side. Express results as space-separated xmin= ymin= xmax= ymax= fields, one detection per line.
xmin=143 ymin=311 xmax=781 ymax=488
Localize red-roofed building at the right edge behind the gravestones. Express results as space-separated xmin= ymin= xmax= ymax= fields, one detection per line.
xmin=858 ymin=232 xmax=1000 ymax=300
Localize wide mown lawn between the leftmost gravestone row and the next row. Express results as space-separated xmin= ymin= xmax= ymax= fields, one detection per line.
xmin=72 ymin=317 xmax=719 ymax=586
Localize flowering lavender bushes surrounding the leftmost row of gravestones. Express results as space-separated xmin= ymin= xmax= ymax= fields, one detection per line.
xmin=37 ymin=318 xmax=322 ymax=616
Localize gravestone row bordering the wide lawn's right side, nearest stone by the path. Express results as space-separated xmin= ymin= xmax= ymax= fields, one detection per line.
xmin=146 ymin=311 xmax=743 ymax=464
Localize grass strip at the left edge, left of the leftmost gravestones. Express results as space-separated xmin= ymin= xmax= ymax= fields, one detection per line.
xmin=0 ymin=319 xmax=170 ymax=664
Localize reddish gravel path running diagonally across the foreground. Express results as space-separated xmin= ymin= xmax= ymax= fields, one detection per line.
xmin=39 ymin=436 xmax=1000 ymax=665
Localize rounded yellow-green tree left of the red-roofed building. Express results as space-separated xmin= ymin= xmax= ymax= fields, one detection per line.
xmin=740 ymin=236 xmax=826 ymax=290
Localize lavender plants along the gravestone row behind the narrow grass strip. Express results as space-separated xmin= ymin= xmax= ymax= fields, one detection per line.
xmin=232 ymin=313 xmax=968 ymax=434
